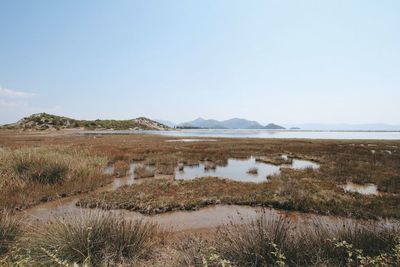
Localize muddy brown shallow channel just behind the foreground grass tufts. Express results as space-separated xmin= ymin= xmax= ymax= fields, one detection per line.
xmin=23 ymin=204 xmax=398 ymax=232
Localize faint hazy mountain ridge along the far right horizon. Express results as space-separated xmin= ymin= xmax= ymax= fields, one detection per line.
xmin=285 ymin=123 xmax=400 ymax=131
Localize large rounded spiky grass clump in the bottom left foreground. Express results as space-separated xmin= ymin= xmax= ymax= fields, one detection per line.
xmin=11 ymin=211 xmax=158 ymax=266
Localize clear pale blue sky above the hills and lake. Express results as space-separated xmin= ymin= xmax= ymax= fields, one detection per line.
xmin=0 ymin=0 xmax=400 ymax=124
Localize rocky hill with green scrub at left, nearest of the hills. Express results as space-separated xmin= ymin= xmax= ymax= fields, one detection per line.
xmin=2 ymin=113 xmax=169 ymax=130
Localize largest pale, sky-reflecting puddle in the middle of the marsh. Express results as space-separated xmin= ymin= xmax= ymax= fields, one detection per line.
xmin=175 ymin=155 xmax=319 ymax=183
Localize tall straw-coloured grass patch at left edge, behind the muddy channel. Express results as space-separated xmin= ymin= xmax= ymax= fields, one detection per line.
xmin=0 ymin=146 xmax=110 ymax=209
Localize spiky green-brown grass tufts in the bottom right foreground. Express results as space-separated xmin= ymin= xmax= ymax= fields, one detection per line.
xmin=215 ymin=212 xmax=400 ymax=266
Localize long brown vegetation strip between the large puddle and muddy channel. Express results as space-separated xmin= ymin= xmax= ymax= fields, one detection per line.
xmin=78 ymin=174 xmax=400 ymax=218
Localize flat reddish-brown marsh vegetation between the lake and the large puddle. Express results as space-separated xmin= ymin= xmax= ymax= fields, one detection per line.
xmin=0 ymin=131 xmax=400 ymax=211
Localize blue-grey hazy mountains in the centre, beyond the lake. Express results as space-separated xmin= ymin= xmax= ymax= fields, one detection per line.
xmin=178 ymin=118 xmax=285 ymax=129
